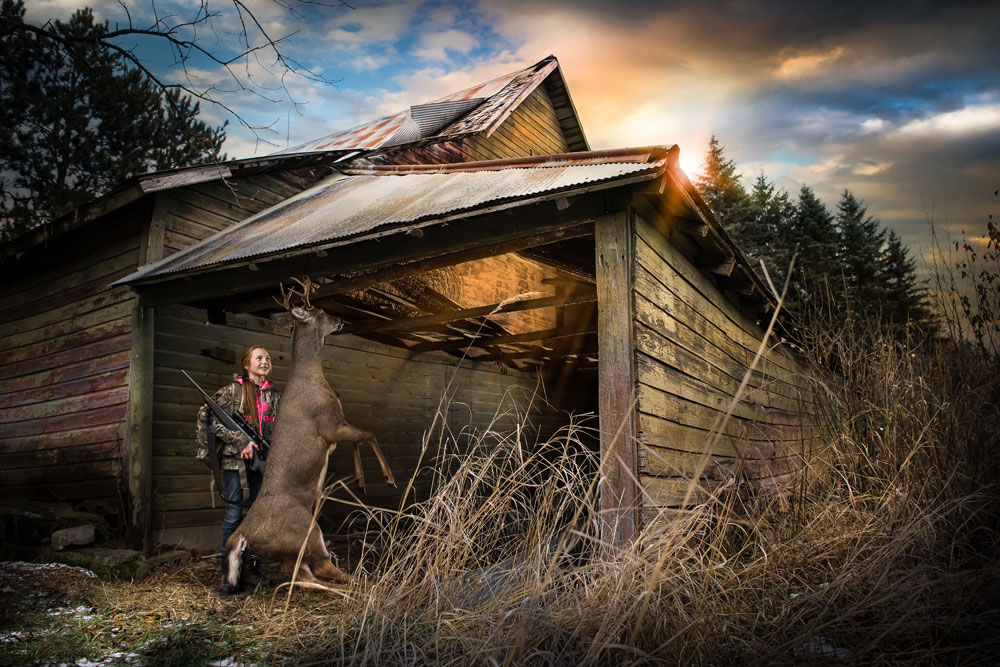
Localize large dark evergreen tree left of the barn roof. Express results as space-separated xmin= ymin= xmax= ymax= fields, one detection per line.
xmin=0 ymin=0 xmax=225 ymax=236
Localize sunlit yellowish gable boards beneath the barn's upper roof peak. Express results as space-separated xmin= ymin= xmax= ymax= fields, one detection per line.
xmin=376 ymin=86 xmax=569 ymax=164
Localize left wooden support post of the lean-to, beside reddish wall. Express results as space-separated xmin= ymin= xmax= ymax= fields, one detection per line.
xmin=123 ymin=296 xmax=153 ymax=552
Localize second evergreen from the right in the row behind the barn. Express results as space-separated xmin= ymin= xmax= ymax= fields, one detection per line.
xmin=836 ymin=190 xmax=885 ymax=312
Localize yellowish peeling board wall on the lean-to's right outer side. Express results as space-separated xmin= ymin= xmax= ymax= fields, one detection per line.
xmin=633 ymin=216 xmax=817 ymax=514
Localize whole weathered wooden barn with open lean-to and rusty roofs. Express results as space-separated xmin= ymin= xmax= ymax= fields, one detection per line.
xmin=0 ymin=57 xmax=818 ymax=548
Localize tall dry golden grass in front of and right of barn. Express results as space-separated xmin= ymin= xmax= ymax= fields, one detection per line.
xmin=252 ymin=312 xmax=1000 ymax=665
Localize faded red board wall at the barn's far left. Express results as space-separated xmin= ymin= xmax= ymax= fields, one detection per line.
xmin=0 ymin=213 xmax=148 ymax=513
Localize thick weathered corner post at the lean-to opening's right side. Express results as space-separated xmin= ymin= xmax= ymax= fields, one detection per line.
xmin=594 ymin=207 xmax=639 ymax=545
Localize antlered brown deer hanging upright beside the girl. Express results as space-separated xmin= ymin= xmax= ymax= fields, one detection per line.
xmin=220 ymin=277 xmax=396 ymax=595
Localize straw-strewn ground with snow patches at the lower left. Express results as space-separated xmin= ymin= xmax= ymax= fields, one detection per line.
xmin=0 ymin=558 xmax=329 ymax=667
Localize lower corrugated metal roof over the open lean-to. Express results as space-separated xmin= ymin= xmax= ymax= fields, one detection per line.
xmin=119 ymin=147 xmax=667 ymax=283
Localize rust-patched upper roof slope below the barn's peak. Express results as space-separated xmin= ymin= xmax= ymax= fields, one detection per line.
xmin=274 ymin=56 xmax=559 ymax=155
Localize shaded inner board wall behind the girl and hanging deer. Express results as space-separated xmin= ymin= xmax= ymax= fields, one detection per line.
xmin=152 ymin=306 xmax=593 ymax=544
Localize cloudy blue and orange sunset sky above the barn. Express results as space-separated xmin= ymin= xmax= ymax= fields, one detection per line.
xmin=27 ymin=0 xmax=1000 ymax=264
